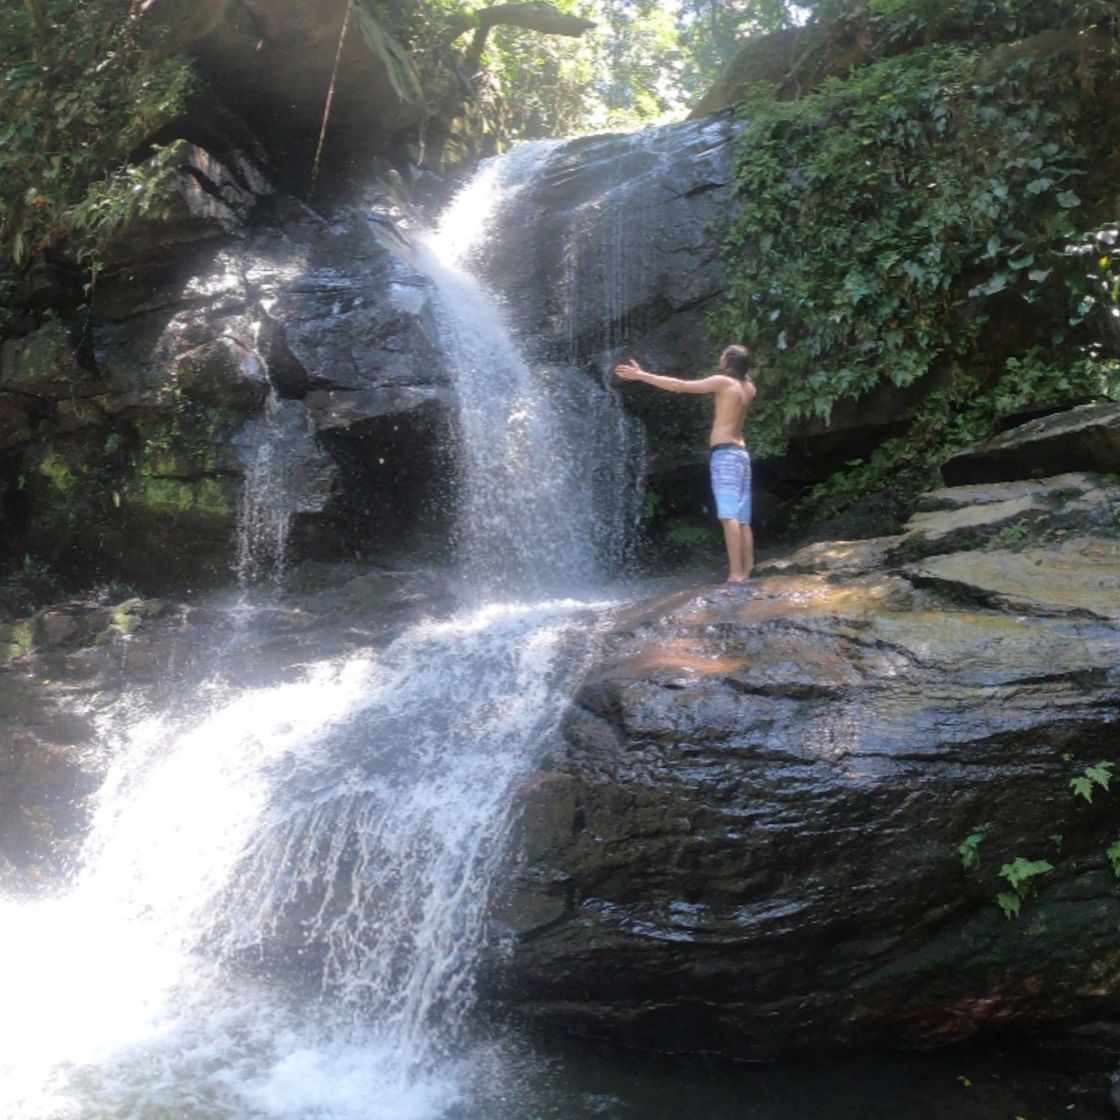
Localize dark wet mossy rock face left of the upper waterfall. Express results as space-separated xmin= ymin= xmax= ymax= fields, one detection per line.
xmin=0 ymin=146 xmax=448 ymax=590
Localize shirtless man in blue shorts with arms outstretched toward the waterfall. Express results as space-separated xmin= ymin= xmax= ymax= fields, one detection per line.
xmin=615 ymin=346 xmax=757 ymax=584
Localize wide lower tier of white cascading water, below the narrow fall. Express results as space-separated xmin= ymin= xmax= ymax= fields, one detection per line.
xmin=0 ymin=601 xmax=596 ymax=1120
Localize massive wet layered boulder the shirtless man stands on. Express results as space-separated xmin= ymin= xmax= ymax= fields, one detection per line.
xmin=502 ymin=407 xmax=1120 ymax=1057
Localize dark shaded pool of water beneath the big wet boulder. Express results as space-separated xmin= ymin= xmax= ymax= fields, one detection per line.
xmin=477 ymin=1042 xmax=1116 ymax=1120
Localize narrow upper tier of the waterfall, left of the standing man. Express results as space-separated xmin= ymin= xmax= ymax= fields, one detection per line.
xmin=416 ymin=142 xmax=644 ymax=594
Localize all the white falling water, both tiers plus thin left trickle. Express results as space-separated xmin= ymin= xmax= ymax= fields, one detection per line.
xmin=0 ymin=144 xmax=636 ymax=1120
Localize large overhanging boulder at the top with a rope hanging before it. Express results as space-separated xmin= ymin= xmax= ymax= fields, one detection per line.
xmin=138 ymin=0 xmax=519 ymax=185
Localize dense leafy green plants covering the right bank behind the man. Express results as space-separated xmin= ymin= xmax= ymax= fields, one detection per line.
xmin=711 ymin=0 xmax=1120 ymax=514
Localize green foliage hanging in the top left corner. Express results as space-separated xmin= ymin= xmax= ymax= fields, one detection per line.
xmin=0 ymin=0 xmax=192 ymax=325
